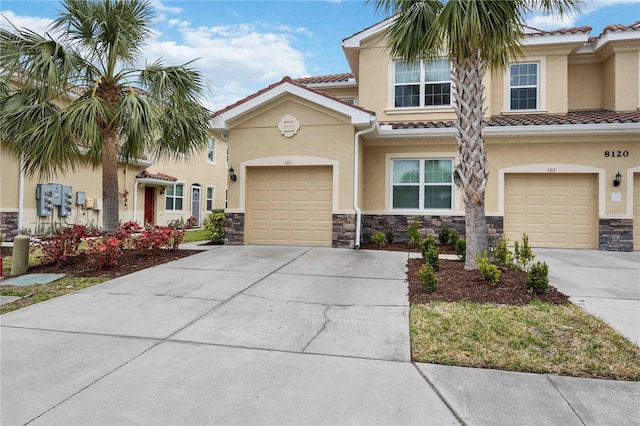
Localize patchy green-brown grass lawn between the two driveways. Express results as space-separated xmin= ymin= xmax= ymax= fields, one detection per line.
xmin=410 ymin=302 xmax=640 ymax=381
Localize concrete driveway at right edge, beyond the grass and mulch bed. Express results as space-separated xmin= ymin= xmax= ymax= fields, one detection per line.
xmin=535 ymin=248 xmax=640 ymax=345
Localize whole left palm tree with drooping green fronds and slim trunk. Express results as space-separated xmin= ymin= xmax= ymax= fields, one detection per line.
xmin=0 ymin=0 xmax=210 ymax=232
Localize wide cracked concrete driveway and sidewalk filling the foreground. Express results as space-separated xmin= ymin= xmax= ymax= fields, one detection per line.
xmin=0 ymin=246 xmax=640 ymax=425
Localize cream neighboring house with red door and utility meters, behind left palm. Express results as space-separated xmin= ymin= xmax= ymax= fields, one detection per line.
xmin=0 ymin=128 xmax=229 ymax=240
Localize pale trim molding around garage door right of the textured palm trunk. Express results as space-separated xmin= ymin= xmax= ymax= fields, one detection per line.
xmin=498 ymin=163 xmax=606 ymax=217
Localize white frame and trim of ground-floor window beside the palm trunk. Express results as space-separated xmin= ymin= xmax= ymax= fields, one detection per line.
xmin=385 ymin=152 xmax=461 ymax=215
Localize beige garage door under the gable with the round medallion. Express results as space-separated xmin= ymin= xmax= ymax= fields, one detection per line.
xmin=246 ymin=167 xmax=333 ymax=246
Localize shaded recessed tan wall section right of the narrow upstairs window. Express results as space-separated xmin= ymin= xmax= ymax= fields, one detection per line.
xmin=568 ymin=63 xmax=602 ymax=110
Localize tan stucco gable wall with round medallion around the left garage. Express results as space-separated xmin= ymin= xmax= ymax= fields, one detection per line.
xmin=229 ymin=96 xmax=354 ymax=215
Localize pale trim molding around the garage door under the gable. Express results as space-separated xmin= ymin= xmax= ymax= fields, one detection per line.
xmin=239 ymin=155 xmax=340 ymax=213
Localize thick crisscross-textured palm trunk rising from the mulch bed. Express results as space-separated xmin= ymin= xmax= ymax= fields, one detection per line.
xmin=452 ymin=51 xmax=489 ymax=270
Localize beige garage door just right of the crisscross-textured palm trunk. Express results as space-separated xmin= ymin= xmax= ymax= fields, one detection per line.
xmin=504 ymin=173 xmax=598 ymax=249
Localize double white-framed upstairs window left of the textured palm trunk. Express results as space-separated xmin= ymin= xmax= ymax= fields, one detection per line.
xmin=394 ymin=59 xmax=451 ymax=108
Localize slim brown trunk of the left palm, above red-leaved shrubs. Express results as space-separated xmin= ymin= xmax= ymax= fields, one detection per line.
xmin=102 ymin=129 xmax=120 ymax=233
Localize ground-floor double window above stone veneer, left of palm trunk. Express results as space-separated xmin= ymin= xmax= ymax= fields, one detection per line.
xmin=391 ymin=159 xmax=453 ymax=209
